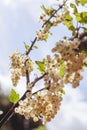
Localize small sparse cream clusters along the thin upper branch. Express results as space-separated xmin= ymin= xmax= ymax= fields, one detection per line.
xmin=36 ymin=11 xmax=69 ymax=41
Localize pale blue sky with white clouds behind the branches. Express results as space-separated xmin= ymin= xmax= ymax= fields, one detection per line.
xmin=0 ymin=0 xmax=87 ymax=130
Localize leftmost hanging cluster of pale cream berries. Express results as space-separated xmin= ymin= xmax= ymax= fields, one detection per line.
xmin=10 ymin=51 xmax=33 ymax=86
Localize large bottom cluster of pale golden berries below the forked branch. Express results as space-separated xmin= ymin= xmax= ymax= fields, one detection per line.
xmin=15 ymin=90 xmax=62 ymax=124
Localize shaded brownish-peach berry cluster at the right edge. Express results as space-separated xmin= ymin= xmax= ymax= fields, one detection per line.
xmin=52 ymin=39 xmax=87 ymax=88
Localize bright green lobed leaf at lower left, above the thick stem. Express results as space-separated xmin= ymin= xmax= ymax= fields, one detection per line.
xmin=9 ymin=89 xmax=19 ymax=104
